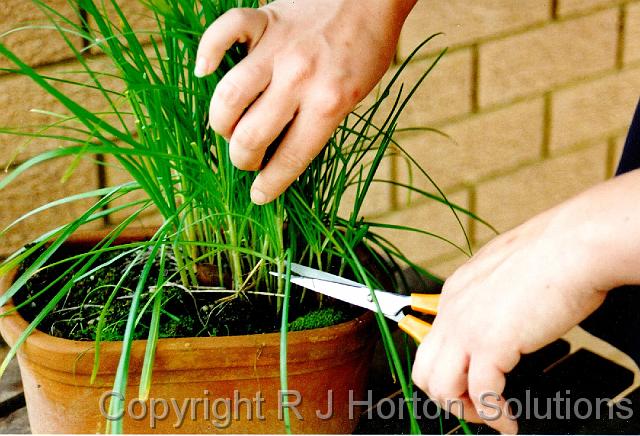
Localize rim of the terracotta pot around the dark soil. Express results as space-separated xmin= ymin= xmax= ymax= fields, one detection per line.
xmin=0 ymin=232 xmax=374 ymax=374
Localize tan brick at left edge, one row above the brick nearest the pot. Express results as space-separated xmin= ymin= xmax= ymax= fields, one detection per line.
xmin=0 ymin=58 xmax=129 ymax=167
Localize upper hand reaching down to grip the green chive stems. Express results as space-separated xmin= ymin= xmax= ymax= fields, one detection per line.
xmin=195 ymin=0 xmax=415 ymax=204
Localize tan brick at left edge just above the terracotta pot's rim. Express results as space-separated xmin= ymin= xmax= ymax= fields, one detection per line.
xmin=0 ymin=159 xmax=102 ymax=256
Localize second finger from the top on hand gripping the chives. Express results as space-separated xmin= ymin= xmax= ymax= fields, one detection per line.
xmin=209 ymin=50 xmax=278 ymax=138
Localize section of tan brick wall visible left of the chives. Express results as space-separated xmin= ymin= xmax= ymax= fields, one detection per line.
xmin=0 ymin=0 xmax=157 ymax=256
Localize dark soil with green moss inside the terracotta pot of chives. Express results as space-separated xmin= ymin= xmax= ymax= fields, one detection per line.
xmin=14 ymin=245 xmax=362 ymax=341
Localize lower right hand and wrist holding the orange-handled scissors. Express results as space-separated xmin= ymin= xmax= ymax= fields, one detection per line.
xmin=413 ymin=171 xmax=640 ymax=433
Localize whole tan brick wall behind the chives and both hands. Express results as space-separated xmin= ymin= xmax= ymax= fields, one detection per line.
xmin=0 ymin=0 xmax=640 ymax=275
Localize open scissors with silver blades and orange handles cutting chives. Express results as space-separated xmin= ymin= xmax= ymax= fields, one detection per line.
xmin=271 ymin=263 xmax=440 ymax=342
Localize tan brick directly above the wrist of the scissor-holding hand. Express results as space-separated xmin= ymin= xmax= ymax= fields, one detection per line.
xmin=476 ymin=143 xmax=607 ymax=241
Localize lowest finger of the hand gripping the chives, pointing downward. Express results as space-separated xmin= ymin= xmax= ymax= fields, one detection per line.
xmin=251 ymin=107 xmax=341 ymax=204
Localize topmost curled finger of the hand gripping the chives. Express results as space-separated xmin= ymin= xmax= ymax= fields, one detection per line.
xmin=194 ymin=8 xmax=267 ymax=77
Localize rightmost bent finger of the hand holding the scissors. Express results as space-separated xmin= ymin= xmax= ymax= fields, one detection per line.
xmin=469 ymin=357 xmax=518 ymax=434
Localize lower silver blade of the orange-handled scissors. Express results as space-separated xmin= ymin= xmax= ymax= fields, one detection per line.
xmin=291 ymin=277 xmax=408 ymax=322
